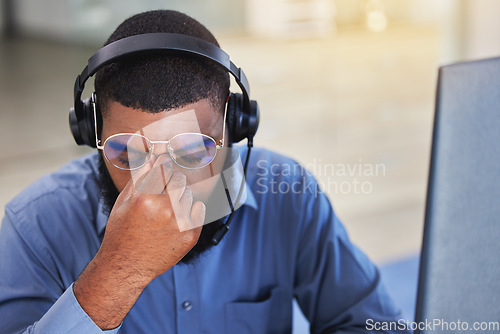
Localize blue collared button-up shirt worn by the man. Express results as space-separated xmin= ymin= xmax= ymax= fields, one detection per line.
xmin=0 ymin=149 xmax=406 ymax=334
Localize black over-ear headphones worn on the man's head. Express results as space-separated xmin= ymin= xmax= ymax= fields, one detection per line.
xmin=69 ymin=33 xmax=259 ymax=148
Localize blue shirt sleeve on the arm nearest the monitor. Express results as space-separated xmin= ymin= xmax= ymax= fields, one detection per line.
xmin=294 ymin=177 xmax=405 ymax=333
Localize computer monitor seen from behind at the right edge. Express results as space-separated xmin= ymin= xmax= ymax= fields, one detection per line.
xmin=415 ymin=58 xmax=500 ymax=333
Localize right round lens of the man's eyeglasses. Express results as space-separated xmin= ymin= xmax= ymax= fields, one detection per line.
xmin=170 ymin=133 xmax=217 ymax=169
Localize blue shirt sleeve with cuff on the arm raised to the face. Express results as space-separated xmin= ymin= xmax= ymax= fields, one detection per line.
xmin=0 ymin=213 xmax=119 ymax=334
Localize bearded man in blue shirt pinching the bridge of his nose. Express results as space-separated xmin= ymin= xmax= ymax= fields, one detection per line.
xmin=0 ymin=11 xmax=406 ymax=333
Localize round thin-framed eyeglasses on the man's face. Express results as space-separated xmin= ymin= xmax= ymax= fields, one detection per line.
xmin=94 ymin=94 xmax=227 ymax=170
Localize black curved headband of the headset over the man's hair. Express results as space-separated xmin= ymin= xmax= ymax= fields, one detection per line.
xmin=74 ymin=33 xmax=250 ymax=112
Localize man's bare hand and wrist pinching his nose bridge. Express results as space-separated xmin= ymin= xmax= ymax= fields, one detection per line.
xmin=73 ymin=161 xmax=205 ymax=330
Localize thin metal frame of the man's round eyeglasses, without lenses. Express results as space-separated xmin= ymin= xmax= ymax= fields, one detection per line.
xmin=92 ymin=93 xmax=227 ymax=170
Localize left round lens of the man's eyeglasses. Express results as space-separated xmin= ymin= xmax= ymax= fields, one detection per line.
xmin=104 ymin=134 xmax=149 ymax=170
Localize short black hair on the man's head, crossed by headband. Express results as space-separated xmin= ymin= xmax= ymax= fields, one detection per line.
xmin=94 ymin=10 xmax=230 ymax=115
